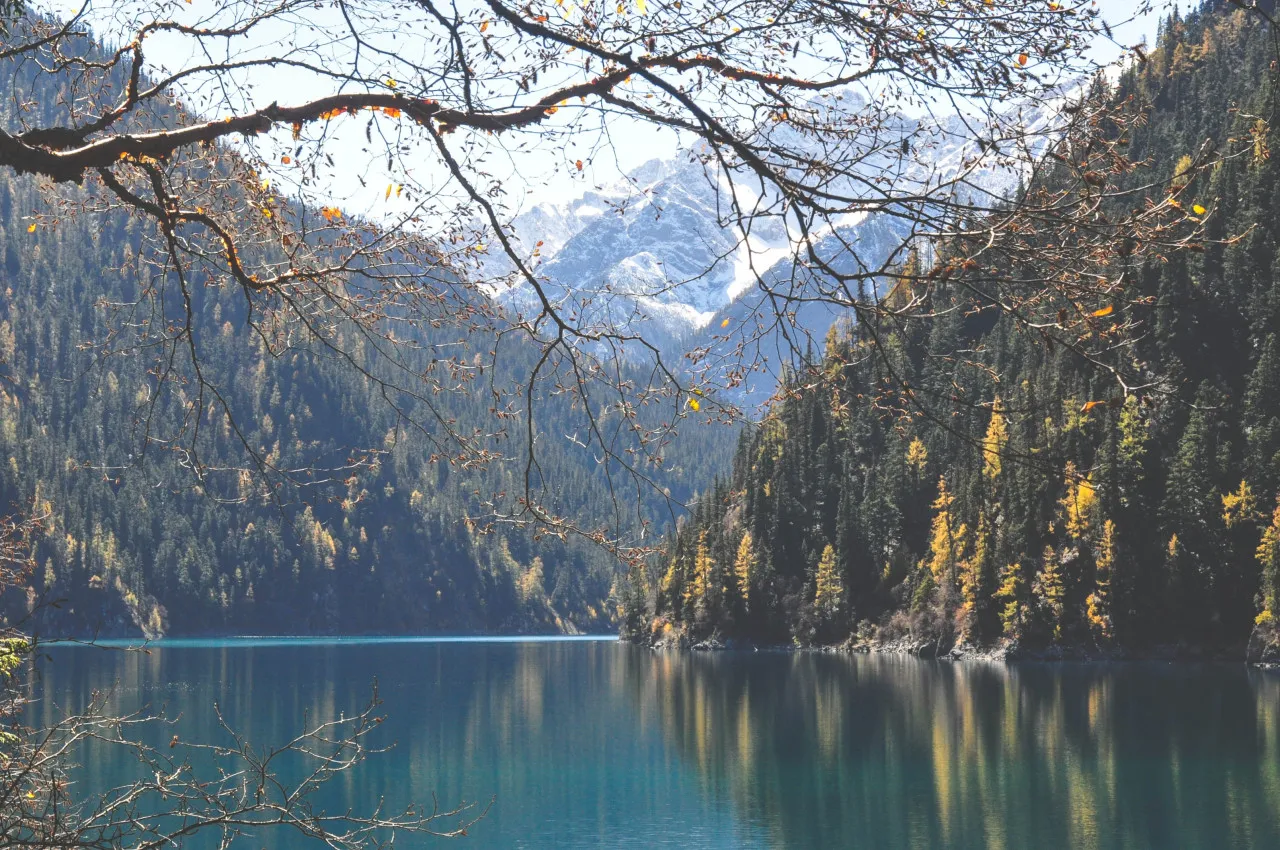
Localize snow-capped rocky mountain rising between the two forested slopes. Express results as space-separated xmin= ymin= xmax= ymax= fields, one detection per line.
xmin=490 ymin=94 xmax=1070 ymax=399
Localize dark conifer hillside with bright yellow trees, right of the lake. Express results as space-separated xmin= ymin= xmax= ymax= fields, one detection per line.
xmin=625 ymin=3 xmax=1280 ymax=655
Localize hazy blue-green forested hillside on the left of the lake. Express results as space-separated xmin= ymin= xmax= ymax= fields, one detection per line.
xmin=0 ymin=26 xmax=732 ymax=635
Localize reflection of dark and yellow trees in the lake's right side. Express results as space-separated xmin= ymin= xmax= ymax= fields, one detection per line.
xmin=630 ymin=653 xmax=1280 ymax=850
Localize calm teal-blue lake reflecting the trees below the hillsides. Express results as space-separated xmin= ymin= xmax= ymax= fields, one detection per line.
xmin=24 ymin=639 xmax=1280 ymax=850
